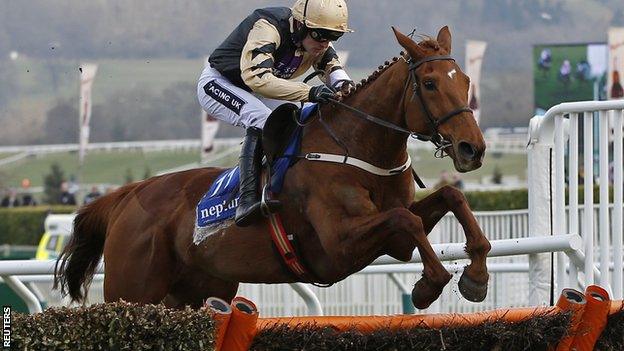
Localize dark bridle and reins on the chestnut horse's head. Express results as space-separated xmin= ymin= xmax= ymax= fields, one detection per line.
xmin=329 ymin=55 xmax=472 ymax=158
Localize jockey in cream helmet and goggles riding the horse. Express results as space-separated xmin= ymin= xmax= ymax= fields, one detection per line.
xmin=197 ymin=0 xmax=353 ymax=226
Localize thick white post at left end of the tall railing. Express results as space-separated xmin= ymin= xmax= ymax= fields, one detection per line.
xmin=527 ymin=116 xmax=552 ymax=306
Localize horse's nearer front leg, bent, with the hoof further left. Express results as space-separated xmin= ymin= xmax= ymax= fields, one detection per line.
xmin=320 ymin=208 xmax=452 ymax=309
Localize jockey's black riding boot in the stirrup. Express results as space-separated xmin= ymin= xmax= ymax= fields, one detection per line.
xmin=234 ymin=127 xmax=281 ymax=227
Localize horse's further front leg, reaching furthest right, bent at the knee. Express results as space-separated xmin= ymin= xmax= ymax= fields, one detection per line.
xmin=410 ymin=186 xmax=491 ymax=302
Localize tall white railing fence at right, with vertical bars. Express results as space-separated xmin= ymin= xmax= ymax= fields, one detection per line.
xmin=528 ymin=100 xmax=624 ymax=304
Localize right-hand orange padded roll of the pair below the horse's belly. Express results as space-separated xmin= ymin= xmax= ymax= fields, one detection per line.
xmin=222 ymin=297 xmax=258 ymax=351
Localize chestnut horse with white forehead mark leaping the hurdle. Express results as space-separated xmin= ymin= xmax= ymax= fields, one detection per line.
xmin=55 ymin=27 xmax=490 ymax=308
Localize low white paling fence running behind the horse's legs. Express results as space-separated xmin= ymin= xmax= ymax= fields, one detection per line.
xmin=0 ymin=210 xmax=588 ymax=316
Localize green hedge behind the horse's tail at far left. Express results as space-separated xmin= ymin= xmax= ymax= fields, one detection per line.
xmin=0 ymin=206 xmax=76 ymax=246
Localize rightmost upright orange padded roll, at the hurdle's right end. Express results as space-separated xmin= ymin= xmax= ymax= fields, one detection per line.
xmin=572 ymin=285 xmax=611 ymax=351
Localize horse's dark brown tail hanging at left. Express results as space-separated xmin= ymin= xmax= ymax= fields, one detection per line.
xmin=53 ymin=183 xmax=136 ymax=302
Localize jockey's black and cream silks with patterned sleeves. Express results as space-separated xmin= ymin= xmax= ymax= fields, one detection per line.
xmin=209 ymin=7 xmax=346 ymax=101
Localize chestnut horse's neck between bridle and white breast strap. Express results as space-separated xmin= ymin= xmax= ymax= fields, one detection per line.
xmin=326 ymin=61 xmax=409 ymax=168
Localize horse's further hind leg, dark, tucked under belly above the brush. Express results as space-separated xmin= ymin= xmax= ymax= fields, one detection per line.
xmin=162 ymin=272 xmax=238 ymax=308
